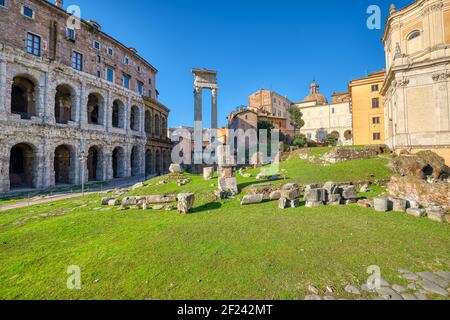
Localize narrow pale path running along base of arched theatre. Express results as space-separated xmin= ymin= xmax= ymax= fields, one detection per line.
xmin=0 ymin=179 xmax=142 ymax=212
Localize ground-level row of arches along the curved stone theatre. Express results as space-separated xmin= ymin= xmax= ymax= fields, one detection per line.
xmin=2 ymin=143 xmax=170 ymax=190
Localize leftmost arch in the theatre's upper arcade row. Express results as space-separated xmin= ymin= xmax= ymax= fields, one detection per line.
xmin=11 ymin=75 xmax=38 ymax=120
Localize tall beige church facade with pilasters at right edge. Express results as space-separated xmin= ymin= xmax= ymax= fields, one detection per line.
xmin=381 ymin=0 xmax=450 ymax=163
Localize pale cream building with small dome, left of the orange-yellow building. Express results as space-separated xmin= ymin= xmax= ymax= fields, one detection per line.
xmin=292 ymin=81 xmax=353 ymax=145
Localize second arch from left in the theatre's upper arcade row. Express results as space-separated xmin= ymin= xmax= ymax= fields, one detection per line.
xmin=54 ymin=84 xmax=76 ymax=124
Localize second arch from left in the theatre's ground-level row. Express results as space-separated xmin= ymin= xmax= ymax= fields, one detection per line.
xmin=53 ymin=144 xmax=76 ymax=185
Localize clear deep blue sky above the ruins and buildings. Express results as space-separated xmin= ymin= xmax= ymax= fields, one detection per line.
xmin=69 ymin=0 xmax=413 ymax=127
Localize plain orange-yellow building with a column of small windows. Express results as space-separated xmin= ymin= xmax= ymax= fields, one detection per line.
xmin=349 ymin=70 xmax=386 ymax=145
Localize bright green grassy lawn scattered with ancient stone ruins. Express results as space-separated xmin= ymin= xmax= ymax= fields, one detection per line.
xmin=0 ymin=151 xmax=450 ymax=299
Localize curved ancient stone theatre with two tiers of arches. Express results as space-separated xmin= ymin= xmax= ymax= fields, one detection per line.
xmin=0 ymin=0 xmax=170 ymax=192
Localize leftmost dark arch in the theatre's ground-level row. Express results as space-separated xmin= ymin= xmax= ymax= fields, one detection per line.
xmin=9 ymin=143 xmax=37 ymax=189
